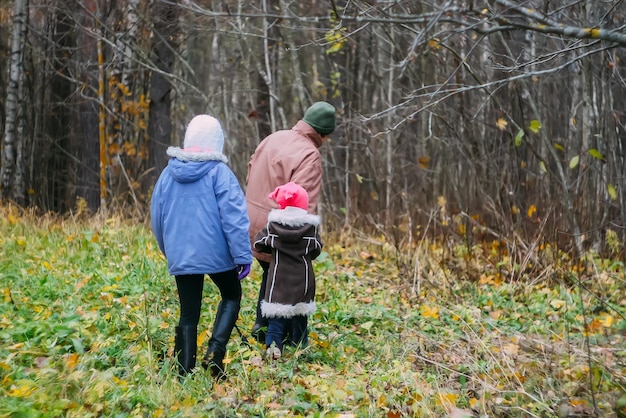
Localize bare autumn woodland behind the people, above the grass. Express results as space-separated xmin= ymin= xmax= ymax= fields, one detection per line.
xmin=0 ymin=0 xmax=626 ymax=264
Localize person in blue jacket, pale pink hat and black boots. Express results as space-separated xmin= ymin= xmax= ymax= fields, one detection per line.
xmin=150 ymin=115 xmax=252 ymax=376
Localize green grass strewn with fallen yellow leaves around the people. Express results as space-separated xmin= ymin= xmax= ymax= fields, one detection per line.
xmin=0 ymin=207 xmax=626 ymax=417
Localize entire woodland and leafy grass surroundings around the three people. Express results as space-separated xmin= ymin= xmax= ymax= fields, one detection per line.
xmin=0 ymin=0 xmax=626 ymax=418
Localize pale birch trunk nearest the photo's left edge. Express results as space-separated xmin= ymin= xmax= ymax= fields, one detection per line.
xmin=0 ymin=0 xmax=28 ymax=205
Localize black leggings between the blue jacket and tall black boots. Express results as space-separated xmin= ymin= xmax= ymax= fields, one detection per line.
xmin=176 ymin=269 xmax=241 ymax=326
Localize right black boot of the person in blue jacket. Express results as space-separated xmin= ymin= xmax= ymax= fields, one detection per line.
xmin=202 ymin=299 xmax=240 ymax=378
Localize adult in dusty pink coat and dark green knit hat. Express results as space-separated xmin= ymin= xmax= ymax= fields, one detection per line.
xmin=246 ymin=102 xmax=335 ymax=341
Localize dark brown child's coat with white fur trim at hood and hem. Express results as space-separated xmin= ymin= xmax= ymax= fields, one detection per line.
xmin=254 ymin=207 xmax=323 ymax=318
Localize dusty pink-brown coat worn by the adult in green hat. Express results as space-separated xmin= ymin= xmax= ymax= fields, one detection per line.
xmin=246 ymin=120 xmax=322 ymax=262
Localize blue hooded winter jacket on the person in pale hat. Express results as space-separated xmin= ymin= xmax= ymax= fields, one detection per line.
xmin=150 ymin=158 xmax=252 ymax=276
